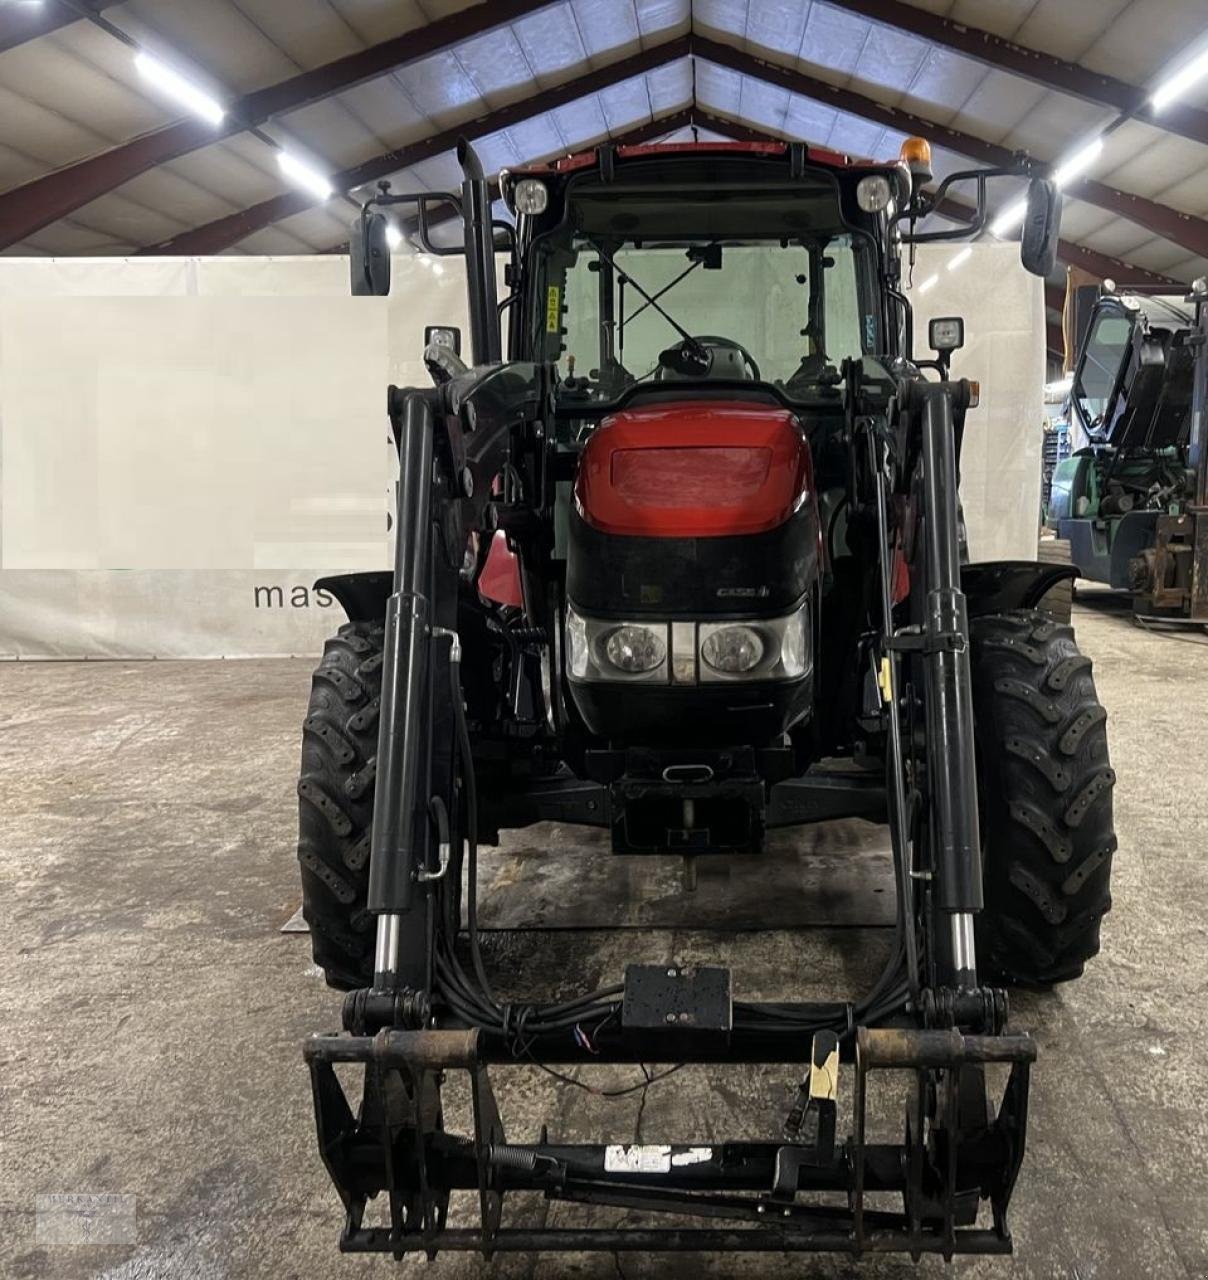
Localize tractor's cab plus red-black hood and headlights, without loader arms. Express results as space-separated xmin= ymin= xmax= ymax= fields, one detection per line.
xmin=503 ymin=143 xmax=895 ymax=752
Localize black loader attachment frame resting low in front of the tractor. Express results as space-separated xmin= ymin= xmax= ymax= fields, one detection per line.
xmin=306 ymin=1027 xmax=1035 ymax=1260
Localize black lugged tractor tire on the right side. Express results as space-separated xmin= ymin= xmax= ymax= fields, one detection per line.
xmin=970 ymin=609 xmax=1116 ymax=984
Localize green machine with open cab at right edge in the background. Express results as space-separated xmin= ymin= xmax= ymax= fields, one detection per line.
xmin=1045 ymin=279 xmax=1208 ymax=622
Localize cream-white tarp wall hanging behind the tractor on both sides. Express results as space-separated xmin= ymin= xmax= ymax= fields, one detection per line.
xmin=0 ymin=246 xmax=1044 ymax=658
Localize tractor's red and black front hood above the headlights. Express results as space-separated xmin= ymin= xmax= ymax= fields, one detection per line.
xmin=567 ymin=396 xmax=822 ymax=618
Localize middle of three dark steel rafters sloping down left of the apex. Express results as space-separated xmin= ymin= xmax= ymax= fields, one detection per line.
xmin=139 ymin=36 xmax=688 ymax=256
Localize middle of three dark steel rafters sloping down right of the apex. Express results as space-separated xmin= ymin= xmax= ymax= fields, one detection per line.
xmin=692 ymin=37 xmax=1208 ymax=257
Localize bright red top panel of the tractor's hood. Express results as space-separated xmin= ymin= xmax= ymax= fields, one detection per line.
xmin=575 ymin=401 xmax=813 ymax=538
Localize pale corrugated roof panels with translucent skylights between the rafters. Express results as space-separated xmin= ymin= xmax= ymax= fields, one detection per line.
xmin=0 ymin=0 xmax=1208 ymax=307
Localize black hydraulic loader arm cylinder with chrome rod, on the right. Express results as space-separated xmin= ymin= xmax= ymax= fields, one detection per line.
xmin=915 ymin=383 xmax=982 ymax=987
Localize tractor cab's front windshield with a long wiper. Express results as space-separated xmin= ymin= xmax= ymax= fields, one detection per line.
xmin=531 ymin=184 xmax=878 ymax=403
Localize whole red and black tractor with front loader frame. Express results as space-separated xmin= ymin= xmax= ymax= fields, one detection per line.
xmin=299 ymin=132 xmax=1115 ymax=1257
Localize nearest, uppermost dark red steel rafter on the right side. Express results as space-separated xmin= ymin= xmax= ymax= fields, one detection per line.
xmin=827 ymin=0 xmax=1208 ymax=146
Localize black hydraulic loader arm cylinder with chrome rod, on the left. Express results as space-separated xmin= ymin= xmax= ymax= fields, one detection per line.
xmin=367 ymin=389 xmax=433 ymax=991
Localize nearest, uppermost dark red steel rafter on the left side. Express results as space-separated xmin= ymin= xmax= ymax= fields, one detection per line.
xmin=0 ymin=0 xmax=553 ymax=250
